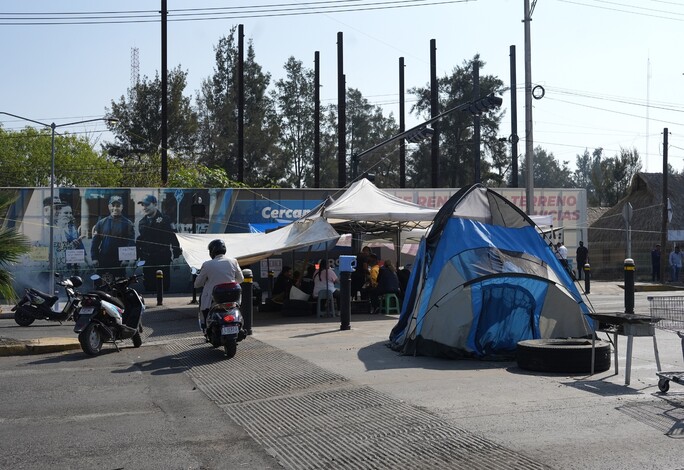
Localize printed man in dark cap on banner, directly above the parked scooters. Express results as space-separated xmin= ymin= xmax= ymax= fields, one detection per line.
xmin=90 ymin=196 xmax=135 ymax=279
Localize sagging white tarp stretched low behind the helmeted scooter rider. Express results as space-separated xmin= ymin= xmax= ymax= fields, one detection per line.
xmin=178 ymin=218 xmax=340 ymax=269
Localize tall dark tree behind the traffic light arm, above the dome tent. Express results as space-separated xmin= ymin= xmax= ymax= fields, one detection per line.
xmin=407 ymin=54 xmax=508 ymax=188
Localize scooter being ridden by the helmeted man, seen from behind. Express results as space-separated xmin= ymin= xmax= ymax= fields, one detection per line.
xmin=200 ymin=282 xmax=247 ymax=359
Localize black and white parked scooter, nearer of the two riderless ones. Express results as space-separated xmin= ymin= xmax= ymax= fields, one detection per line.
xmin=74 ymin=262 xmax=145 ymax=356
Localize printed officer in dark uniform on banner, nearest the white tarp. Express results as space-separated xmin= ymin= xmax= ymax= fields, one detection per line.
xmin=135 ymin=194 xmax=183 ymax=292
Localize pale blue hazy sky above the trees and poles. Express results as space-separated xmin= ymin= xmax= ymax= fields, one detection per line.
xmin=0 ymin=0 xmax=684 ymax=172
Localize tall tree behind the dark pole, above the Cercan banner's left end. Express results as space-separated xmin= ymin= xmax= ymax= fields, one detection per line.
xmin=197 ymin=26 xmax=282 ymax=186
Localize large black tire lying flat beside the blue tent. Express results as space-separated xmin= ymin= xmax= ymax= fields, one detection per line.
xmin=516 ymin=338 xmax=610 ymax=373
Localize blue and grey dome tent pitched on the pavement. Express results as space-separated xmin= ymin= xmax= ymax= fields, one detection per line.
xmin=390 ymin=184 xmax=593 ymax=358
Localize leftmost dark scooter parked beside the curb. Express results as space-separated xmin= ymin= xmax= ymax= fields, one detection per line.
xmin=12 ymin=273 xmax=83 ymax=326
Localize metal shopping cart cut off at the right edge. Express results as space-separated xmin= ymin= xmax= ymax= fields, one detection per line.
xmin=648 ymin=295 xmax=684 ymax=393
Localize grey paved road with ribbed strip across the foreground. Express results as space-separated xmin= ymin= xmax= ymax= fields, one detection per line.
xmin=0 ymin=283 xmax=684 ymax=470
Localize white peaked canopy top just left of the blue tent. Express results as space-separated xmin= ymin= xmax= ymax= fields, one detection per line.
xmin=316 ymin=178 xmax=437 ymax=234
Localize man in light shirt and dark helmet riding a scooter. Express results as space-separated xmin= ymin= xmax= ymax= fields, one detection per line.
xmin=195 ymin=239 xmax=245 ymax=333
